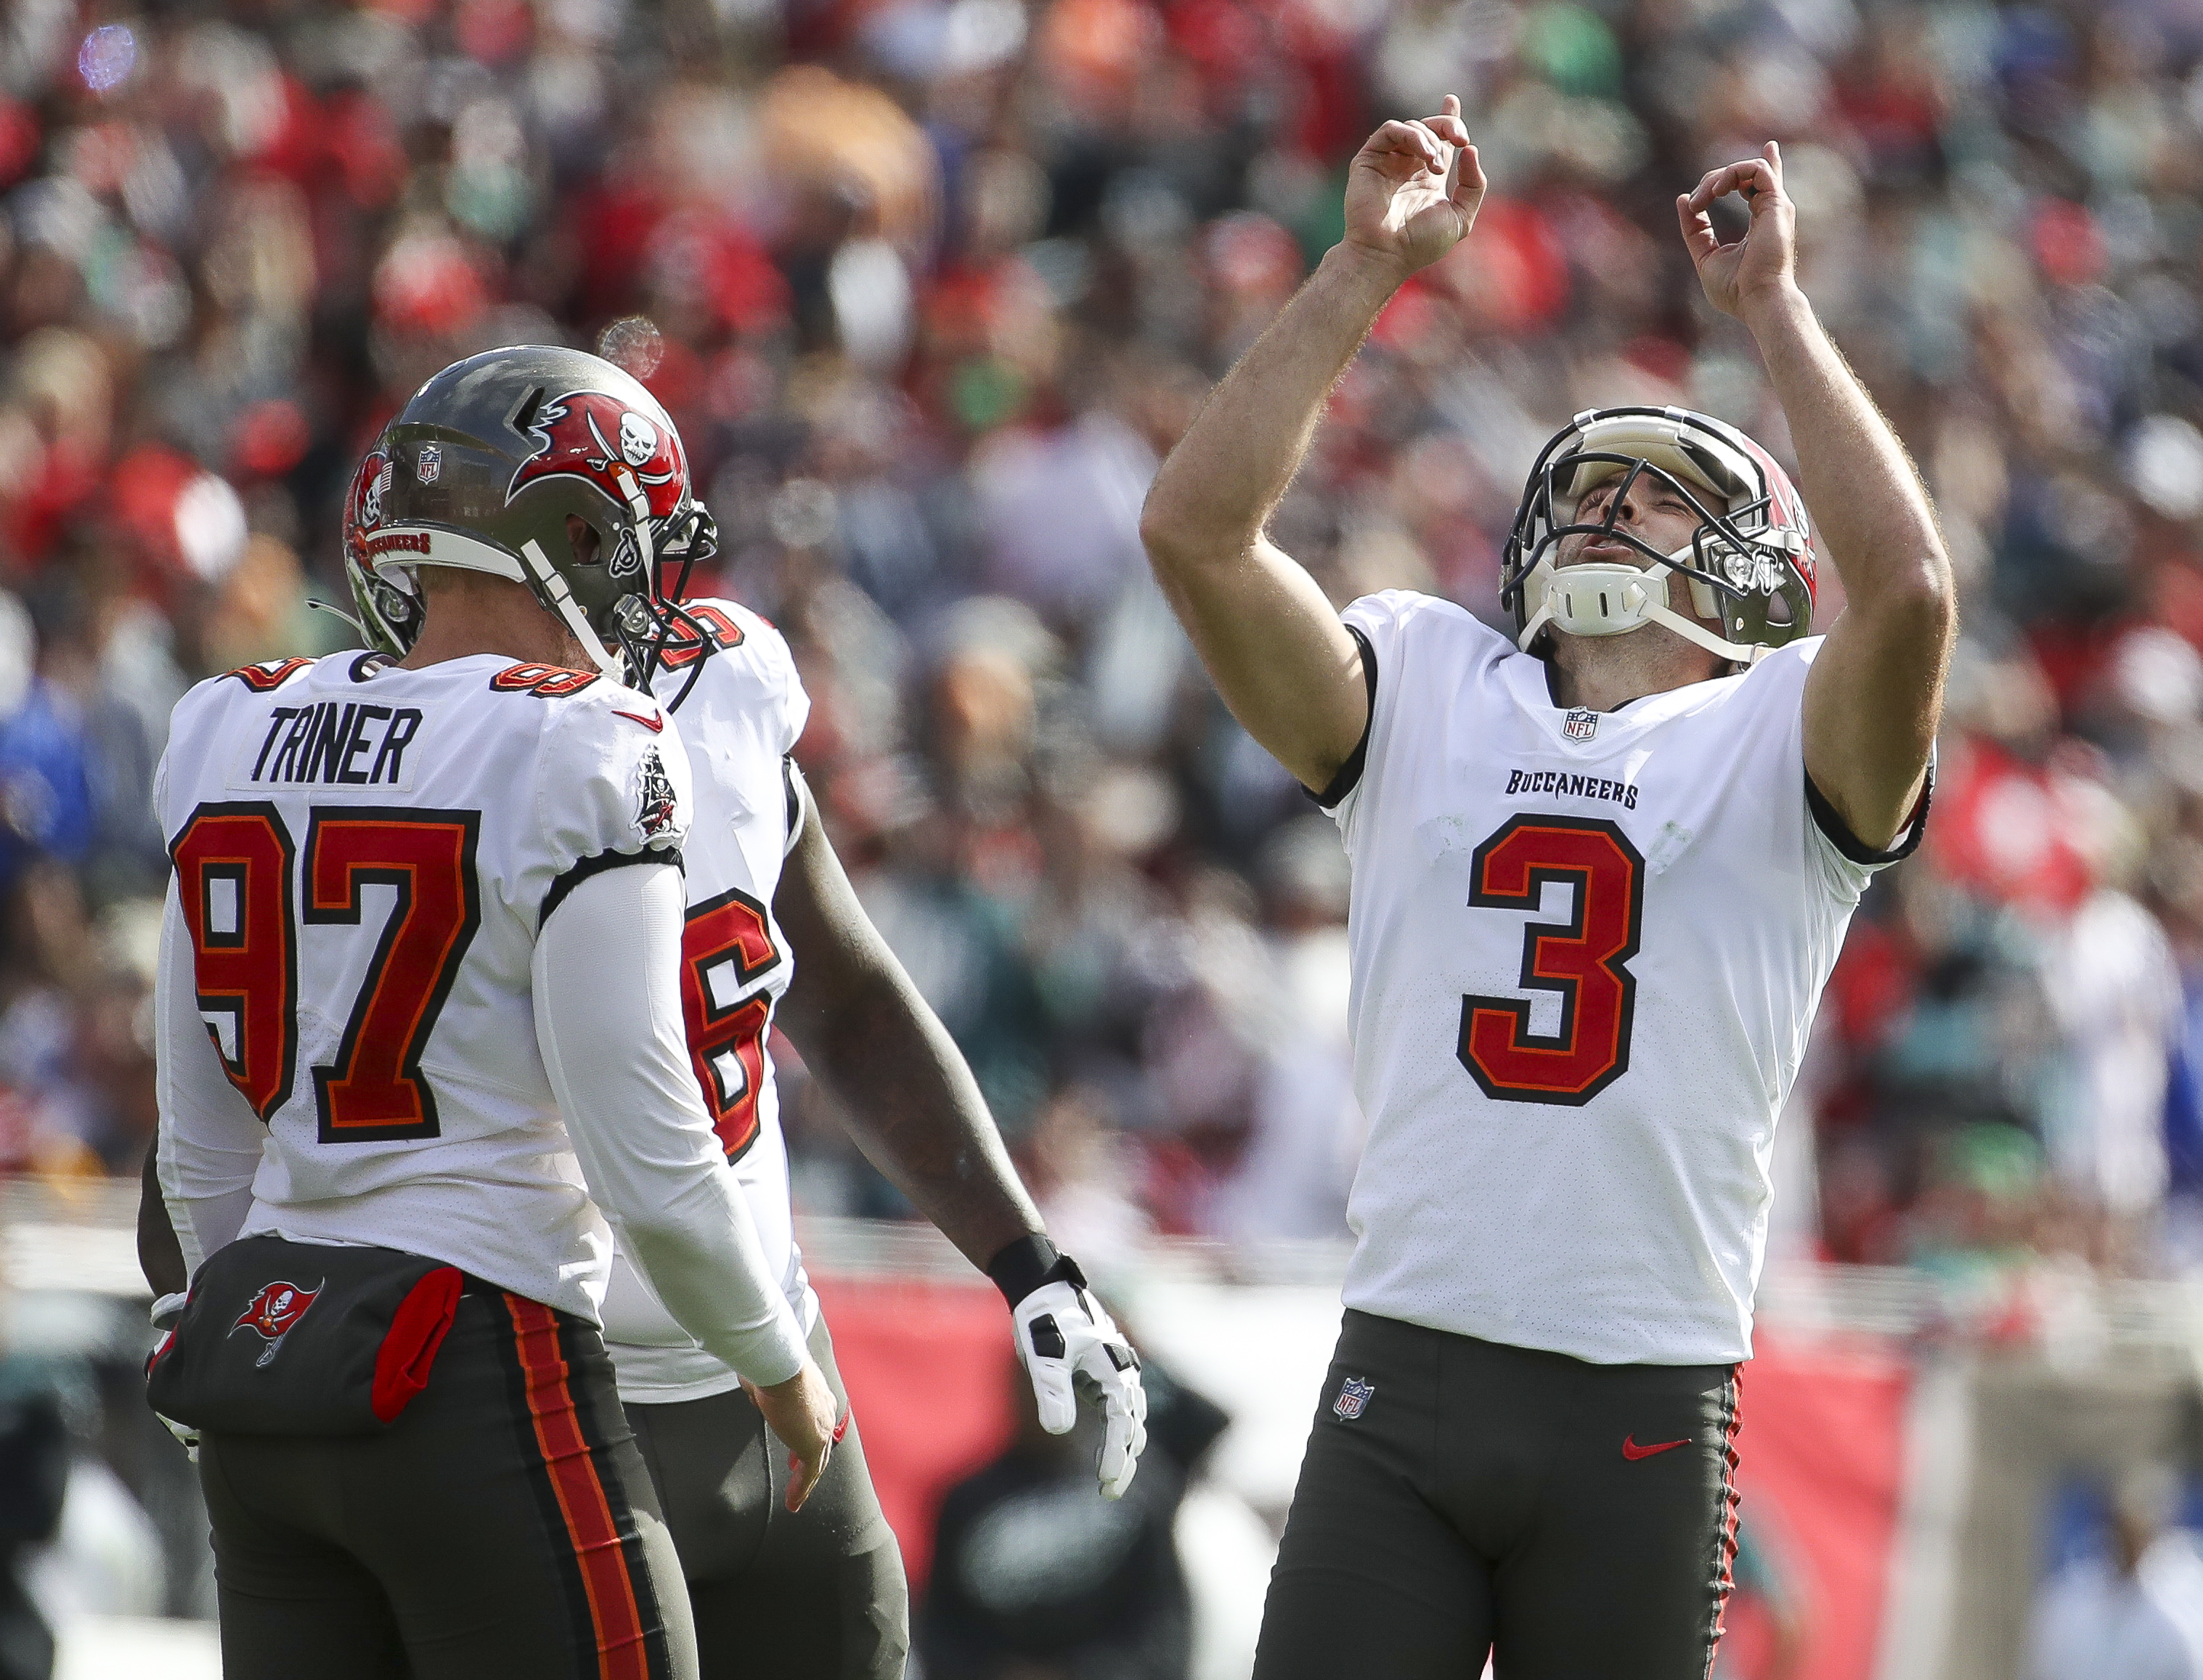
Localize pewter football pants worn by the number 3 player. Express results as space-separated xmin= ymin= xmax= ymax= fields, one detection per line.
xmin=1253 ymin=1313 xmax=1738 ymax=1680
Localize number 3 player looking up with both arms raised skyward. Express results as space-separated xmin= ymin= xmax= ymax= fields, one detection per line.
xmin=1141 ymin=99 xmax=1954 ymax=1680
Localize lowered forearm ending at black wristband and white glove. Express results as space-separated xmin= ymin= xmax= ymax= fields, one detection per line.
xmin=789 ymin=966 xmax=1042 ymax=1271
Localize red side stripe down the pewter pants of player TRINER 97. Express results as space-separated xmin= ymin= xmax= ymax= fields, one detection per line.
xmin=505 ymin=1292 xmax=650 ymax=1680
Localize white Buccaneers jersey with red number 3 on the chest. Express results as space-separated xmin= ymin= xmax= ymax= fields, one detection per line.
xmin=1333 ymin=590 xmax=1919 ymax=1365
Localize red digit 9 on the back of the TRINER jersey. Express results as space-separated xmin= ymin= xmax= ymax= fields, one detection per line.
xmin=170 ymin=799 xmax=298 ymax=1125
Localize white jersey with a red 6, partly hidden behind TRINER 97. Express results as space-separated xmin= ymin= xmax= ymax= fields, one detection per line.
xmin=603 ymin=599 xmax=820 ymax=1403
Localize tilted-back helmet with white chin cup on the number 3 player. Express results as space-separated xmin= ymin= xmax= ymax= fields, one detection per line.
xmin=1500 ymin=407 xmax=1813 ymax=665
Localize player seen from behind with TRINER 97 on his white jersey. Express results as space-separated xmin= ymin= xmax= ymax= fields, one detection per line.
xmin=145 ymin=348 xmax=837 ymax=1680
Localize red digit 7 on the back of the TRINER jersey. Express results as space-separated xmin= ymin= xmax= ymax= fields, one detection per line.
xmin=300 ymin=806 xmax=482 ymax=1143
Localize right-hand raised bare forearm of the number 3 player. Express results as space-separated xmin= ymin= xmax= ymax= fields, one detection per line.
xmin=1745 ymin=286 xmax=1952 ymax=621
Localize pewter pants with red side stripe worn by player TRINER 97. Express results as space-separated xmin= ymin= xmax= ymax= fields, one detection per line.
xmin=198 ymin=1279 xmax=696 ymax=1680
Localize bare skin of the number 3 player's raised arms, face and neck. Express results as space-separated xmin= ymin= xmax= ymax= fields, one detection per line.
xmin=1139 ymin=94 xmax=1956 ymax=848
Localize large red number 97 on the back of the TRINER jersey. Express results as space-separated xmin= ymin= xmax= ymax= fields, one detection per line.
xmin=174 ymin=804 xmax=482 ymax=1143
